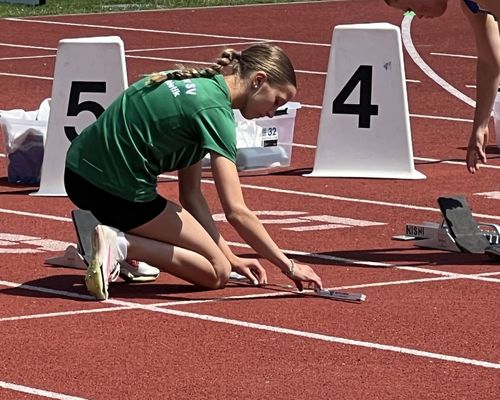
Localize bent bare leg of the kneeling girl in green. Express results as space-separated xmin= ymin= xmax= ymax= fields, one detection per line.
xmin=125 ymin=201 xmax=231 ymax=289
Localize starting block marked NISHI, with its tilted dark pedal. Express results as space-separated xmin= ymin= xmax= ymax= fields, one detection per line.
xmin=392 ymin=196 xmax=500 ymax=256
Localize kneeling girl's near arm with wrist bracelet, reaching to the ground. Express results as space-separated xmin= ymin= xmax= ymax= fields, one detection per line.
xmin=211 ymin=152 xmax=321 ymax=289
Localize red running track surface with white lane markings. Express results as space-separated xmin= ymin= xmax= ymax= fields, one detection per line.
xmin=0 ymin=0 xmax=500 ymax=400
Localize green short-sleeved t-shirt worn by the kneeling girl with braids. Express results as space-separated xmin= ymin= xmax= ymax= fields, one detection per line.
xmin=66 ymin=75 xmax=236 ymax=201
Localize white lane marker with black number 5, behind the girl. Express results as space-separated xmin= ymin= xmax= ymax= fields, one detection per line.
xmin=34 ymin=36 xmax=128 ymax=196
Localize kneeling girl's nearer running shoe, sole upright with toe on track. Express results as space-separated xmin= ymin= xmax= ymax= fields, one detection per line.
xmin=85 ymin=225 xmax=120 ymax=300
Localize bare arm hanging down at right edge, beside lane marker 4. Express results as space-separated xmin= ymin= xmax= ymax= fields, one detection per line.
xmin=462 ymin=4 xmax=500 ymax=173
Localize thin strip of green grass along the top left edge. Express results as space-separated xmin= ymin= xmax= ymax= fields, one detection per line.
xmin=0 ymin=0 xmax=320 ymax=17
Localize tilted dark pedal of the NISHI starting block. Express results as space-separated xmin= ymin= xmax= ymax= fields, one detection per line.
xmin=437 ymin=196 xmax=500 ymax=256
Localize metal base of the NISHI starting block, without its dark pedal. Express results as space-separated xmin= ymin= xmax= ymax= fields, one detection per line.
xmin=392 ymin=220 xmax=500 ymax=253
